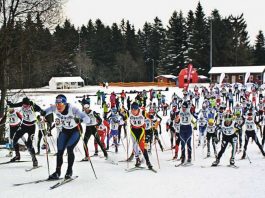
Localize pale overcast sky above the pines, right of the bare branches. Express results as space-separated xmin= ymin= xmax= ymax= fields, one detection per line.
xmin=64 ymin=0 xmax=265 ymax=43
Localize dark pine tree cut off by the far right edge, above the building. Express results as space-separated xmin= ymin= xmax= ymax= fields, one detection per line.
xmin=254 ymin=30 xmax=265 ymax=65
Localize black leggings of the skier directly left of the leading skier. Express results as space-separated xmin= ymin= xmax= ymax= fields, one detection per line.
xmin=13 ymin=124 xmax=35 ymax=156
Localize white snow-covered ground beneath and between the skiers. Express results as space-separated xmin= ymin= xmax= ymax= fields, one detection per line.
xmin=0 ymin=86 xmax=265 ymax=198
